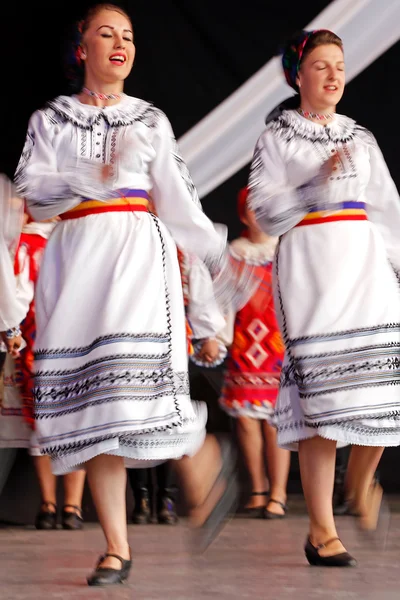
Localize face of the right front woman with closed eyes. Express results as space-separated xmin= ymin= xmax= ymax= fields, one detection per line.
xmin=297 ymin=44 xmax=345 ymax=112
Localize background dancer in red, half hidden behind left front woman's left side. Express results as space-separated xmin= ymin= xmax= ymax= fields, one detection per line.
xmin=0 ymin=214 xmax=85 ymax=530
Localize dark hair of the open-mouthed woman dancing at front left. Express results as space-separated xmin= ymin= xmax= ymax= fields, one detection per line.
xmin=65 ymin=2 xmax=133 ymax=92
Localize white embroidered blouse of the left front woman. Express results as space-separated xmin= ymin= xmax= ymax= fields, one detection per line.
xmin=15 ymin=95 xmax=227 ymax=260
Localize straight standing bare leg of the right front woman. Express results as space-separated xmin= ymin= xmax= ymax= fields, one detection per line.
xmin=299 ymin=437 xmax=345 ymax=556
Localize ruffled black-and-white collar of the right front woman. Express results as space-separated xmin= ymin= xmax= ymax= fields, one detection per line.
xmin=268 ymin=110 xmax=359 ymax=142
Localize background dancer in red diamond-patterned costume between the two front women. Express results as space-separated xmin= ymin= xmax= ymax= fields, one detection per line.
xmin=220 ymin=188 xmax=290 ymax=519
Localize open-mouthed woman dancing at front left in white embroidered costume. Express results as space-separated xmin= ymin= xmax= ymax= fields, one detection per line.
xmin=16 ymin=4 xmax=237 ymax=585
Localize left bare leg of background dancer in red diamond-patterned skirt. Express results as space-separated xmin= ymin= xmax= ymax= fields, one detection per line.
xmin=236 ymin=417 xmax=268 ymax=508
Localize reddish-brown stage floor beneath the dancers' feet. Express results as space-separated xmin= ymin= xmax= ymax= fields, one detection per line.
xmin=0 ymin=498 xmax=400 ymax=600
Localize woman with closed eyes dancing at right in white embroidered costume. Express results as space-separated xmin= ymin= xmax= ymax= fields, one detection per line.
xmin=249 ymin=30 xmax=400 ymax=566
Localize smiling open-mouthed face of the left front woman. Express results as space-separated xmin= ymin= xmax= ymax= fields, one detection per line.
xmin=81 ymin=9 xmax=135 ymax=89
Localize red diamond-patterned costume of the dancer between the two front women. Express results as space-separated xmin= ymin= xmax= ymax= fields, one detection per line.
xmin=220 ymin=190 xmax=284 ymax=420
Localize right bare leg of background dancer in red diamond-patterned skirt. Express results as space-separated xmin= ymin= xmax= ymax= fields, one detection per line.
xmin=263 ymin=421 xmax=290 ymax=515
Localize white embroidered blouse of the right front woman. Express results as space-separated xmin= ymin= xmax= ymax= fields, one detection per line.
xmin=248 ymin=110 xmax=400 ymax=271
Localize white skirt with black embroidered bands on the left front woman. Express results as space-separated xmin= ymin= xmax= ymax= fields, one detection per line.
xmin=34 ymin=212 xmax=207 ymax=474
